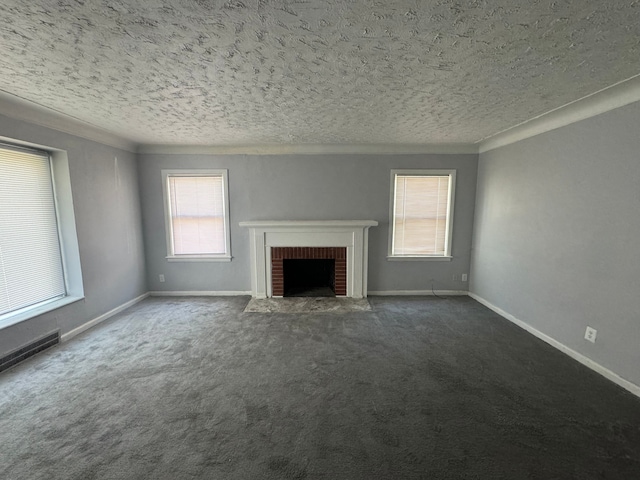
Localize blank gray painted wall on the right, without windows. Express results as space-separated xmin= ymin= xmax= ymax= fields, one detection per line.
xmin=470 ymin=103 xmax=640 ymax=385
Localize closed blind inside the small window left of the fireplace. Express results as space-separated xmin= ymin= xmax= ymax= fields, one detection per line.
xmin=167 ymin=175 xmax=228 ymax=255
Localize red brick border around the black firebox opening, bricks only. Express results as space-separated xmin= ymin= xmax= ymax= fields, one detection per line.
xmin=271 ymin=247 xmax=347 ymax=297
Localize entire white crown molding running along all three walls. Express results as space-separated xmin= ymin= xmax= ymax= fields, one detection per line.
xmin=0 ymin=74 xmax=640 ymax=155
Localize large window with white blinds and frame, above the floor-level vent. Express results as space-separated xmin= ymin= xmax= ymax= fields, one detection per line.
xmin=0 ymin=140 xmax=83 ymax=328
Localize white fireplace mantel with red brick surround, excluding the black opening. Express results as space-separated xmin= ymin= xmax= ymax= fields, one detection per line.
xmin=240 ymin=220 xmax=378 ymax=298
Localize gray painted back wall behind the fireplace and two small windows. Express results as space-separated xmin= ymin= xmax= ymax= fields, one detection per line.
xmin=139 ymin=154 xmax=477 ymax=291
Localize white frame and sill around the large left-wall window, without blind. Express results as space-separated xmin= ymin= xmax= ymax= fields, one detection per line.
xmin=0 ymin=137 xmax=84 ymax=330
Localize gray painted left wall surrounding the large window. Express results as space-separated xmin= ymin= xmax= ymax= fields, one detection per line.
xmin=0 ymin=116 xmax=147 ymax=355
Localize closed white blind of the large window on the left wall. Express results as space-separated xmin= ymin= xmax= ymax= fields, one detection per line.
xmin=0 ymin=146 xmax=66 ymax=315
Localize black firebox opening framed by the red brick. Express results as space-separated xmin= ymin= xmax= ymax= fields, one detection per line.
xmin=282 ymin=259 xmax=336 ymax=297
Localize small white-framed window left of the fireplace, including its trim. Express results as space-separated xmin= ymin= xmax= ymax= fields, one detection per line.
xmin=162 ymin=170 xmax=231 ymax=261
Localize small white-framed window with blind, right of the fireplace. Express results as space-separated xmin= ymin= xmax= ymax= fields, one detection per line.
xmin=389 ymin=170 xmax=456 ymax=260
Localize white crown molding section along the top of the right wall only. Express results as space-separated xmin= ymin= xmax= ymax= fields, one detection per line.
xmin=478 ymin=75 xmax=640 ymax=153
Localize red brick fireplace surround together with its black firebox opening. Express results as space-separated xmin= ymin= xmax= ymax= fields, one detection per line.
xmin=271 ymin=247 xmax=347 ymax=297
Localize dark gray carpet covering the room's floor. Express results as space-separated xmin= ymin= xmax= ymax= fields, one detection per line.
xmin=0 ymin=297 xmax=640 ymax=480
